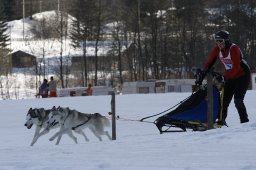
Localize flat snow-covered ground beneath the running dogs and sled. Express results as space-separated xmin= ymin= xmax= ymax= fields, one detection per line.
xmin=0 ymin=91 xmax=256 ymax=170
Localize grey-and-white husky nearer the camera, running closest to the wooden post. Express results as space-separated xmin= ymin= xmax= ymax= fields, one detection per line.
xmin=48 ymin=107 xmax=111 ymax=145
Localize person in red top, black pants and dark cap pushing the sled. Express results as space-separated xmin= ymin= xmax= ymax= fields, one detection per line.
xmin=196 ymin=30 xmax=251 ymax=125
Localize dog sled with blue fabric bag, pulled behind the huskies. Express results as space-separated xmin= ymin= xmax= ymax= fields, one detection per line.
xmin=141 ymin=69 xmax=224 ymax=133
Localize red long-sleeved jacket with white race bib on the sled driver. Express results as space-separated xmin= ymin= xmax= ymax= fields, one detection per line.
xmin=204 ymin=44 xmax=245 ymax=80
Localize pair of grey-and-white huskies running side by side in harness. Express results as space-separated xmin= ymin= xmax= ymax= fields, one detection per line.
xmin=25 ymin=106 xmax=111 ymax=146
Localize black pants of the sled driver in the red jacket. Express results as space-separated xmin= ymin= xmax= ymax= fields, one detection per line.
xmin=222 ymin=73 xmax=251 ymax=123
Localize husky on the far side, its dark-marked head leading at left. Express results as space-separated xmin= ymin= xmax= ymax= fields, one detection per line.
xmin=25 ymin=107 xmax=89 ymax=146
